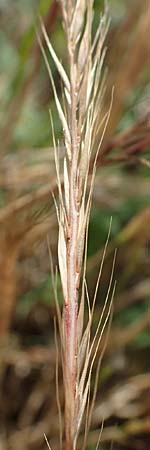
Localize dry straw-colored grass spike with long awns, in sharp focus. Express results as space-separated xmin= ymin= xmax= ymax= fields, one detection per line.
xmin=41 ymin=0 xmax=115 ymax=450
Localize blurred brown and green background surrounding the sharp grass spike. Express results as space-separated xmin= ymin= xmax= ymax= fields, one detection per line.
xmin=0 ymin=0 xmax=150 ymax=450
